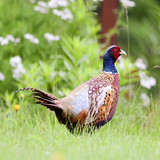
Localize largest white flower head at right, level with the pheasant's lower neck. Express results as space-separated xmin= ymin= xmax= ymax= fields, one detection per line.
xmin=139 ymin=73 xmax=156 ymax=89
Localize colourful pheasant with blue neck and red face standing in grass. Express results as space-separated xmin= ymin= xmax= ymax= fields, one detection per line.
xmin=17 ymin=45 xmax=126 ymax=131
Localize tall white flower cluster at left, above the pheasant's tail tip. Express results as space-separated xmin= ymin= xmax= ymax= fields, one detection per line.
xmin=10 ymin=56 xmax=25 ymax=80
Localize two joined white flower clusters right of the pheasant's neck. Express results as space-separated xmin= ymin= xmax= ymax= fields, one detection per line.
xmin=135 ymin=58 xmax=156 ymax=89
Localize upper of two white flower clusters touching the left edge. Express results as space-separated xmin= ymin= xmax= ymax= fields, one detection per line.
xmin=0 ymin=35 xmax=20 ymax=46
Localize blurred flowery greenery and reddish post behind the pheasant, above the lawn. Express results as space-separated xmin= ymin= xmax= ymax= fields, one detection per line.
xmin=0 ymin=0 xmax=160 ymax=124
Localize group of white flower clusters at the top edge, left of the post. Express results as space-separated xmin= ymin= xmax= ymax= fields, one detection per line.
xmin=34 ymin=0 xmax=73 ymax=20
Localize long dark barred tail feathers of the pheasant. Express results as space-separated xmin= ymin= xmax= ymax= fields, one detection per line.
xmin=16 ymin=87 xmax=62 ymax=111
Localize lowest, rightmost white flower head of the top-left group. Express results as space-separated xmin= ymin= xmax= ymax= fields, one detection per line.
xmin=53 ymin=8 xmax=73 ymax=20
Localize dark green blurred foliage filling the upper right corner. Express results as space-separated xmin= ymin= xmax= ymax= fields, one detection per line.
xmin=118 ymin=0 xmax=160 ymax=92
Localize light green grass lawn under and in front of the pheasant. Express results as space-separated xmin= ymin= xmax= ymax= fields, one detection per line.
xmin=0 ymin=100 xmax=160 ymax=160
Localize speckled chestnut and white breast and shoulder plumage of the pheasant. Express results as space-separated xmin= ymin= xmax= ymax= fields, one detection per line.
xmin=86 ymin=72 xmax=119 ymax=125
